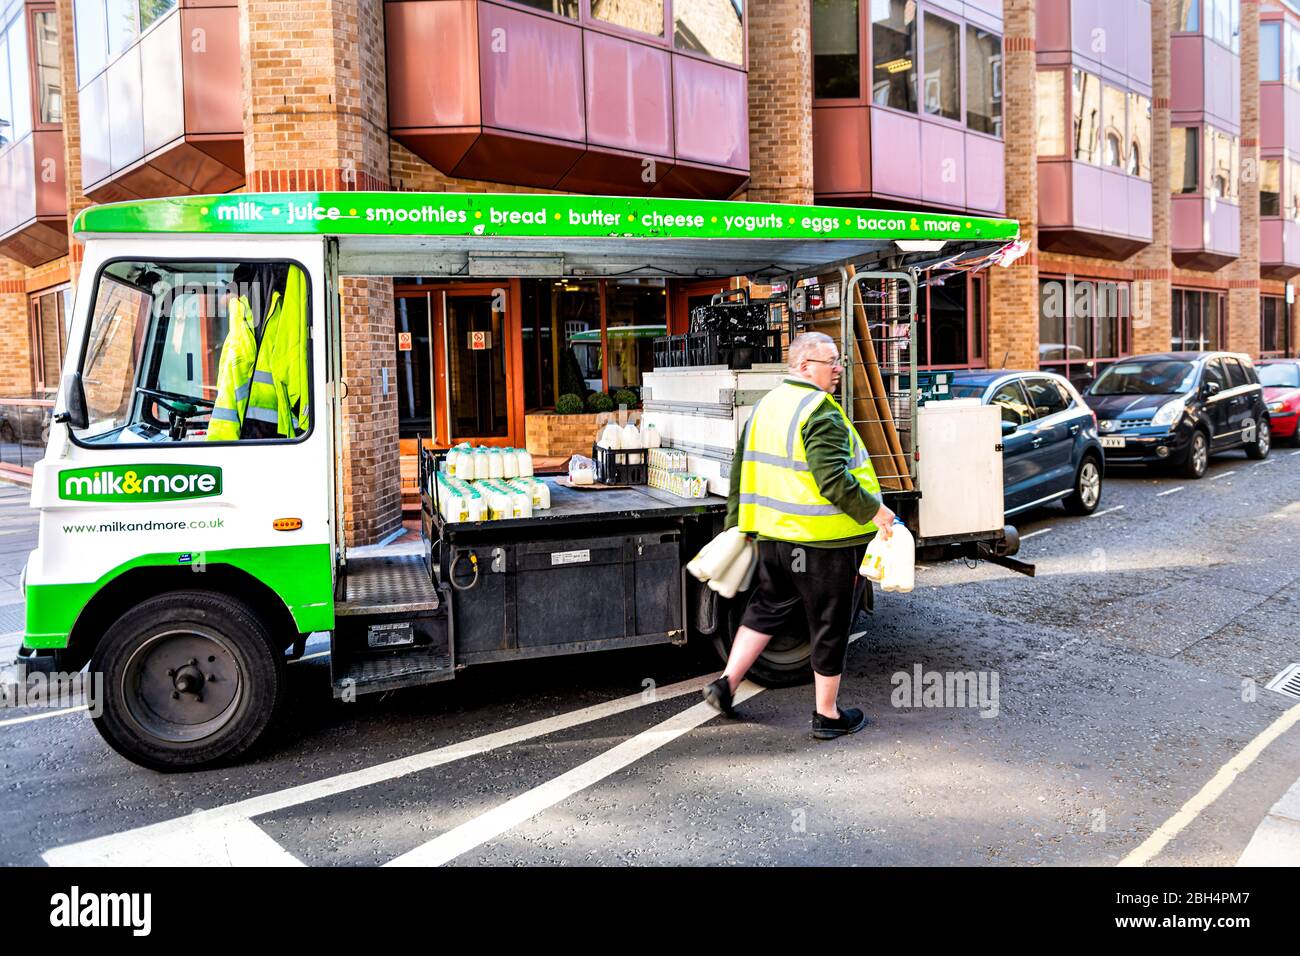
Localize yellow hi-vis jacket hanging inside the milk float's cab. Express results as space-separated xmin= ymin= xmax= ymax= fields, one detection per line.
xmin=208 ymin=265 xmax=311 ymax=441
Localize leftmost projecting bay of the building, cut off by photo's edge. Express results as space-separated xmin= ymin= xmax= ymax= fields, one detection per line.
xmin=0 ymin=3 xmax=68 ymax=267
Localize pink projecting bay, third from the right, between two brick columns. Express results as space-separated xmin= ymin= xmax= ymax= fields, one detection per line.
xmin=1037 ymin=0 xmax=1153 ymax=259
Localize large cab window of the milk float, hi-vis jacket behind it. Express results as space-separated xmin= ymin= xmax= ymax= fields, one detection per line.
xmin=74 ymin=260 xmax=309 ymax=445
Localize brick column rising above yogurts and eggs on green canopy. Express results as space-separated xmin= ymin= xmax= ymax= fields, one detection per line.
xmin=746 ymin=0 xmax=811 ymax=204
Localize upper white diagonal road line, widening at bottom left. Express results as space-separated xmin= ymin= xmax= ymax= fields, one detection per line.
xmin=42 ymin=675 xmax=712 ymax=866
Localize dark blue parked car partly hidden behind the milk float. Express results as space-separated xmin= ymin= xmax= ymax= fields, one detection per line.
xmin=952 ymin=369 xmax=1106 ymax=515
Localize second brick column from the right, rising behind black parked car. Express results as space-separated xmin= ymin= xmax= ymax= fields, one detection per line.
xmin=1130 ymin=0 xmax=1174 ymax=354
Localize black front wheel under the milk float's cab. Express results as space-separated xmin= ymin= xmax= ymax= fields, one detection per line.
xmin=90 ymin=591 xmax=285 ymax=771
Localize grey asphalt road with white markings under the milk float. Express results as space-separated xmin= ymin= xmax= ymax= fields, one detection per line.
xmin=0 ymin=447 xmax=1300 ymax=865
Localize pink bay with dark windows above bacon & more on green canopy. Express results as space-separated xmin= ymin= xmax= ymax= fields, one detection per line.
xmin=813 ymin=0 xmax=1006 ymax=215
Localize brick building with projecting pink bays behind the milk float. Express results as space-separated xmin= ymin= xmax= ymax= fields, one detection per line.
xmin=0 ymin=0 xmax=1300 ymax=542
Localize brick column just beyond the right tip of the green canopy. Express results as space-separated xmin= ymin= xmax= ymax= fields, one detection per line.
xmin=987 ymin=0 xmax=1039 ymax=368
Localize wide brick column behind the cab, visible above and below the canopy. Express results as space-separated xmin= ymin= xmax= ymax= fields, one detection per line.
xmin=239 ymin=0 xmax=402 ymax=545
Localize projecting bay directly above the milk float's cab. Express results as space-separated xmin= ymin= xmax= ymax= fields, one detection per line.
xmin=78 ymin=4 xmax=244 ymax=202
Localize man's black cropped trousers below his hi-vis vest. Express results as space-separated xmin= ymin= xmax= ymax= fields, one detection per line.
xmin=741 ymin=541 xmax=867 ymax=678
